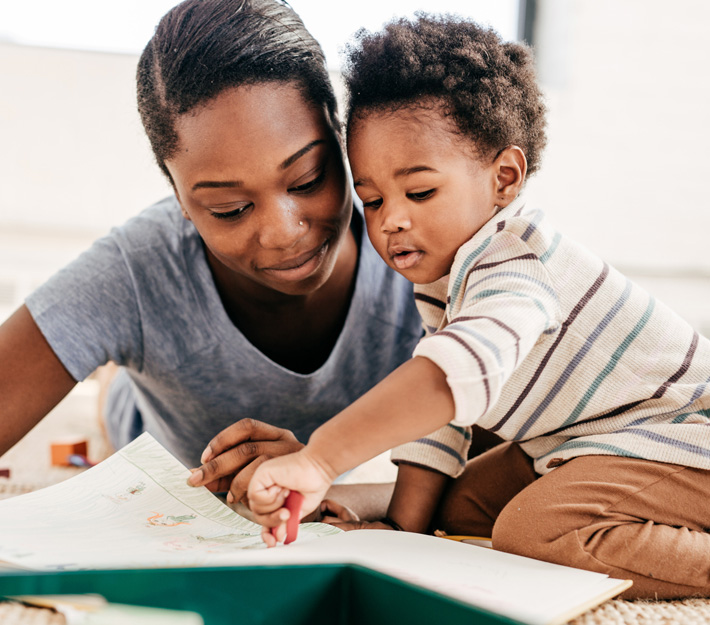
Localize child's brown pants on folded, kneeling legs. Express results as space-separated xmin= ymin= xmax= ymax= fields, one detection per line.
xmin=434 ymin=443 xmax=710 ymax=599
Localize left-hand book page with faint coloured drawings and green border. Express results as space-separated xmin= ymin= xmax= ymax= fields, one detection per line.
xmin=0 ymin=434 xmax=341 ymax=571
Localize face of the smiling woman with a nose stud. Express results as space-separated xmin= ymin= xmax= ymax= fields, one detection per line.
xmin=166 ymin=83 xmax=352 ymax=295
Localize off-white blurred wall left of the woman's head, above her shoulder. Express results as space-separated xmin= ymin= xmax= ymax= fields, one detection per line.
xmin=0 ymin=43 xmax=169 ymax=320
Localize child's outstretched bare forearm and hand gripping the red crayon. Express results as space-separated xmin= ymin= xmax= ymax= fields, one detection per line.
xmin=248 ymin=357 xmax=455 ymax=544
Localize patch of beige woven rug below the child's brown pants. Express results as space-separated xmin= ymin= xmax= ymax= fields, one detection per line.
xmin=570 ymin=599 xmax=710 ymax=625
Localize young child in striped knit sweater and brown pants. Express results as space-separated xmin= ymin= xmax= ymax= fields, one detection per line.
xmin=248 ymin=15 xmax=710 ymax=598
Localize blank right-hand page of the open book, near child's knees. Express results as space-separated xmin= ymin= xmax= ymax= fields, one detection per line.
xmin=269 ymin=530 xmax=631 ymax=625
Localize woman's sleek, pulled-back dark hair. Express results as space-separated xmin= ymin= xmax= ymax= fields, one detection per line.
xmin=137 ymin=0 xmax=340 ymax=178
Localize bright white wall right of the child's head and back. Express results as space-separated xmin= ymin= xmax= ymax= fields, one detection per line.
xmin=529 ymin=0 xmax=710 ymax=334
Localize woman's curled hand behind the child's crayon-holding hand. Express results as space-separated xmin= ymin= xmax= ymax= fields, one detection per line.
xmin=188 ymin=419 xmax=303 ymax=505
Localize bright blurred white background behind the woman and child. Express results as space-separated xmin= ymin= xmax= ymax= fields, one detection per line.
xmin=0 ymin=0 xmax=710 ymax=335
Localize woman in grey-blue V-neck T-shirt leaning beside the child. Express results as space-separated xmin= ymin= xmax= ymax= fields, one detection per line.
xmin=0 ymin=0 xmax=421 ymax=516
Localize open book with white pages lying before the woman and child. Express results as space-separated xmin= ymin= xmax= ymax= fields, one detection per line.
xmin=0 ymin=434 xmax=631 ymax=625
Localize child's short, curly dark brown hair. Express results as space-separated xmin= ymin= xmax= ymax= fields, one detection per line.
xmin=344 ymin=13 xmax=546 ymax=174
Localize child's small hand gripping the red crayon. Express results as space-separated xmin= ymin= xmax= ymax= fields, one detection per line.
xmin=247 ymin=448 xmax=337 ymax=547
